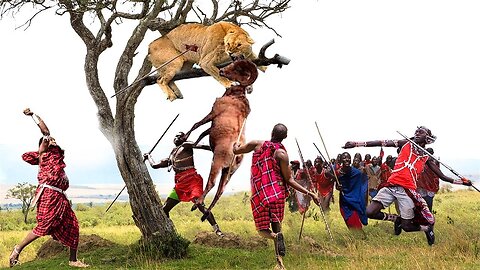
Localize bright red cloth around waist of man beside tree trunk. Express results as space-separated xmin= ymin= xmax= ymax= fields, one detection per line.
xmin=175 ymin=168 xmax=203 ymax=202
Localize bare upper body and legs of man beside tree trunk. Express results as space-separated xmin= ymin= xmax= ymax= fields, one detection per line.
xmin=143 ymin=132 xmax=223 ymax=234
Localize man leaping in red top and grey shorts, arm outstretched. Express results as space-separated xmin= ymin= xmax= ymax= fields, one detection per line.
xmin=343 ymin=126 xmax=472 ymax=245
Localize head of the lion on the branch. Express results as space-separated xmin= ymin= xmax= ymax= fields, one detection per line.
xmin=223 ymin=28 xmax=254 ymax=58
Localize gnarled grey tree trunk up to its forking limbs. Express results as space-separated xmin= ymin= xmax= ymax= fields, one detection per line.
xmin=85 ymin=44 xmax=178 ymax=243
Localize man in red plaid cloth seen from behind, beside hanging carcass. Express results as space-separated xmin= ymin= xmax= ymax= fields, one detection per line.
xmin=233 ymin=124 xmax=319 ymax=269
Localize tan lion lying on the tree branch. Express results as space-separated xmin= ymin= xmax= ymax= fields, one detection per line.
xmin=148 ymin=22 xmax=265 ymax=101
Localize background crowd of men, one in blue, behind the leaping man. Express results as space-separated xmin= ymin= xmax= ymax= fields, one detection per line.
xmin=287 ymin=141 xmax=454 ymax=234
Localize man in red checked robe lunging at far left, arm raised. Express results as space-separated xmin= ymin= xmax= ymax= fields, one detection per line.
xmin=9 ymin=108 xmax=89 ymax=267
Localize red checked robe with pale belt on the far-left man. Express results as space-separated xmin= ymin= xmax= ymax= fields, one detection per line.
xmin=22 ymin=146 xmax=79 ymax=249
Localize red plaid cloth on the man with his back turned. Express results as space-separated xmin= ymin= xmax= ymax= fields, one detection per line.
xmin=250 ymin=141 xmax=286 ymax=230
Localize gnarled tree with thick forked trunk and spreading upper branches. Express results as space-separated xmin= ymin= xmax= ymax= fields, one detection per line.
xmin=0 ymin=0 xmax=290 ymax=258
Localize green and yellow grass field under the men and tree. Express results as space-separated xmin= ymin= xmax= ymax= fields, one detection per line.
xmin=0 ymin=190 xmax=480 ymax=269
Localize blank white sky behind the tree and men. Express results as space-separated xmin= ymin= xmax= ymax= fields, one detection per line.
xmin=0 ymin=0 xmax=480 ymax=194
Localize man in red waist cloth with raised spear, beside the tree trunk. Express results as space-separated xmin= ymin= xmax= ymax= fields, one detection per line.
xmin=143 ymin=132 xmax=224 ymax=237
